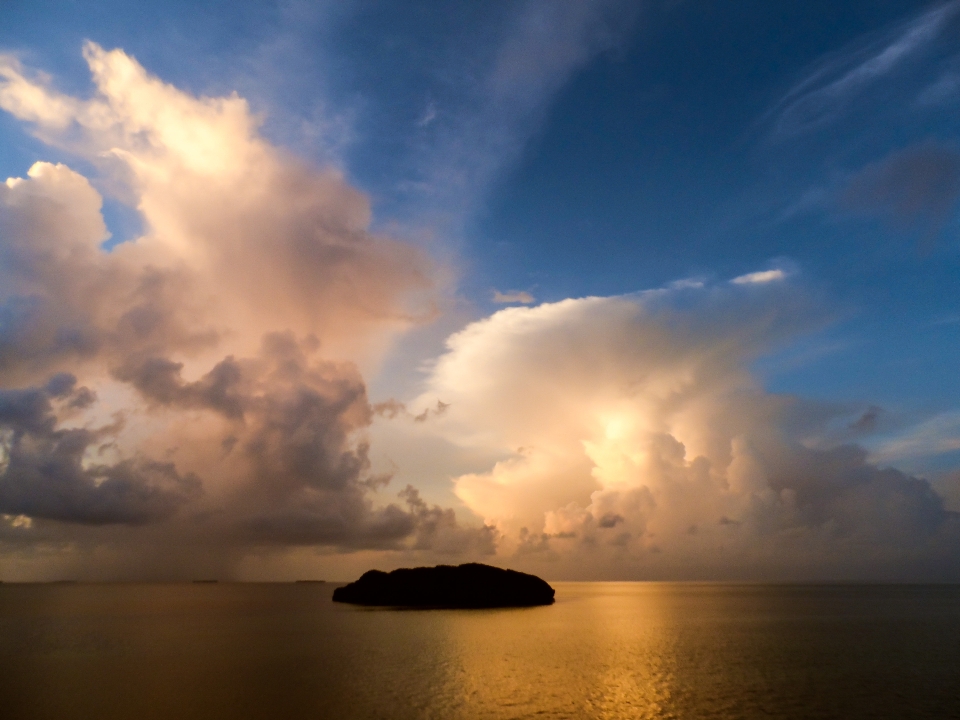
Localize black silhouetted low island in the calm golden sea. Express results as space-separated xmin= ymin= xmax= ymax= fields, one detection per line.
xmin=333 ymin=563 xmax=554 ymax=608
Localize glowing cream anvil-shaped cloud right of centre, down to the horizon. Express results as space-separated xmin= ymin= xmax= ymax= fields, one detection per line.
xmin=422 ymin=283 xmax=960 ymax=579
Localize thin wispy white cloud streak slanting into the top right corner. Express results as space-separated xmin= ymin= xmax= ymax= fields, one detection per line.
xmin=772 ymin=0 xmax=960 ymax=136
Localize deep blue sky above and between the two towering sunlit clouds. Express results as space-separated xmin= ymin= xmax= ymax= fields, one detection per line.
xmin=0 ymin=0 xmax=960 ymax=572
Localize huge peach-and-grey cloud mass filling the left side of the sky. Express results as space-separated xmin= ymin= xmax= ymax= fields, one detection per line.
xmin=0 ymin=43 xmax=489 ymax=572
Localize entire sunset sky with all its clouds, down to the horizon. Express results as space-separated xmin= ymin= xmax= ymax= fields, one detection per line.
xmin=0 ymin=0 xmax=960 ymax=582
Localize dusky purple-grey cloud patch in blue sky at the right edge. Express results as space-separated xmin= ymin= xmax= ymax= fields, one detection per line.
xmin=840 ymin=142 xmax=960 ymax=245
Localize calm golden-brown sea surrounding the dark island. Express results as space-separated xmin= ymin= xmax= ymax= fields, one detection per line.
xmin=0 ymin=582 xmax=960 ymax=720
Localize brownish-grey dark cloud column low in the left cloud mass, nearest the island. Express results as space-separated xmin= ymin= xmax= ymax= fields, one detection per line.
xmin=115 ymin=333 xmax=494 ymax=553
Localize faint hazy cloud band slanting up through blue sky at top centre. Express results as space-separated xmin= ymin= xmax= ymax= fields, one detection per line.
xmin=407 ymin=0 xmax=643 ymax=228
